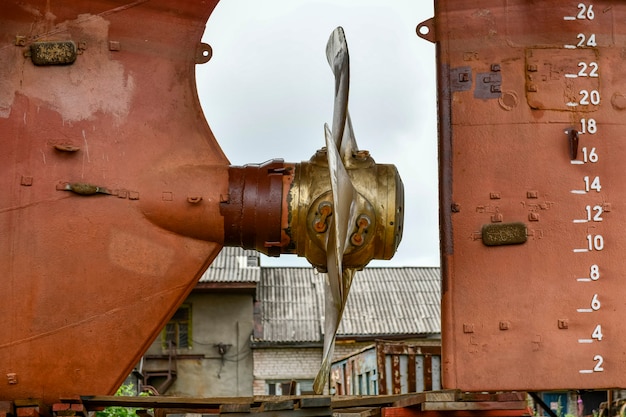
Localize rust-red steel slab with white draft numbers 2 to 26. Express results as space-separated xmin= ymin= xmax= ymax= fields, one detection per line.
xmin=434 ymin=0 xmax=626 ymax=391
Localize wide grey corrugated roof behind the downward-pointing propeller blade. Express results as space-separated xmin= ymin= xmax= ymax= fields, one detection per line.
xmin=252 ymin=267 xmax=441 ymax=342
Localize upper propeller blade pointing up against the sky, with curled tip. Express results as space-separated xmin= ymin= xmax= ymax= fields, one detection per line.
xmin=326 ymin=26 xmax=350 ymax=149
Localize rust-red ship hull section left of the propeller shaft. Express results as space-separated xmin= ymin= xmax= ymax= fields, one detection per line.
xmin=0 ymin=0 xmax=228 ymax=403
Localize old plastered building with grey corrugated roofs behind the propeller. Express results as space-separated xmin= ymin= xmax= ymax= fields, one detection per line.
xmin=140 ymin=248 xmax=441 ymax=397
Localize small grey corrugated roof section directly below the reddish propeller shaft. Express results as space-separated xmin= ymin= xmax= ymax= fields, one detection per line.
xmin=200 ymin=247 xmax=261 ymax=282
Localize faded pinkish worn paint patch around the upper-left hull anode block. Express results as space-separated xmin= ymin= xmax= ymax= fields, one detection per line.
xmin=0 ymin=14 xmax=135 ymax=123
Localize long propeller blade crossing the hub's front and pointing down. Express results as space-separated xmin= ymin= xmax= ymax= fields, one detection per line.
xmin=313 ymin=125 xmax=358 ymax=394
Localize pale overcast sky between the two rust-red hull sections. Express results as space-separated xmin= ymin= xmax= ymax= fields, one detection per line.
xmin=197 ymin=0 xmax=439 ymax=266
